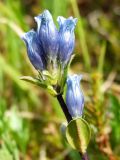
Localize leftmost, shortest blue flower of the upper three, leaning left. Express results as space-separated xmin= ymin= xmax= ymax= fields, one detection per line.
xmin=22 ymin=30 xmax=45 ymax=70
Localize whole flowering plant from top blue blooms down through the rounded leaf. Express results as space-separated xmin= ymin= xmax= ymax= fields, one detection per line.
xmin=22 ymin=10 xmax=90 ymax=153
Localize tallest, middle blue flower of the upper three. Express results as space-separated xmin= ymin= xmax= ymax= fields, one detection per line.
xmin=35 ymin=10 xmax=58 ymax=59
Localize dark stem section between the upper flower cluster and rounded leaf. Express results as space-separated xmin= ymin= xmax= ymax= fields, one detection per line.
xmin=57 ymin=94 xmax=72 ymax=123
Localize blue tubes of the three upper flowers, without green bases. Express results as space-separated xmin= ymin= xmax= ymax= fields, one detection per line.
xmin=22 ymin=10 xmax=77 ymax=70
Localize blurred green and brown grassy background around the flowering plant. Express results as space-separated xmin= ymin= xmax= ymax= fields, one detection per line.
xmin=0 ymin=0 xmax=120 ymax=160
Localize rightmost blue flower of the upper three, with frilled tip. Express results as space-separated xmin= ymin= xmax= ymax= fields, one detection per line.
xmin=57 ymin=16 xmax=77 ymax=64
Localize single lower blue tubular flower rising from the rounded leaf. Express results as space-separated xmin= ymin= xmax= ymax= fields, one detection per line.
xmin=66 ymin=74 xmax=84 ymax=117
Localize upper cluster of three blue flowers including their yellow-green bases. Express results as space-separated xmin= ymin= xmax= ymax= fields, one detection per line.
xmin=22 ymin=10 xmax=77 ymax=95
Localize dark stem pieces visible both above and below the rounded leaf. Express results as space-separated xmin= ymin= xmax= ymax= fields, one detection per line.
xmin=57 ymin=94 xmax=89 ymax=160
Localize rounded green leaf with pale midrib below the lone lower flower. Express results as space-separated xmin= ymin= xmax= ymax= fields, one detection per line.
xmin=66 ymin=117 xmax=91 ymax=153
